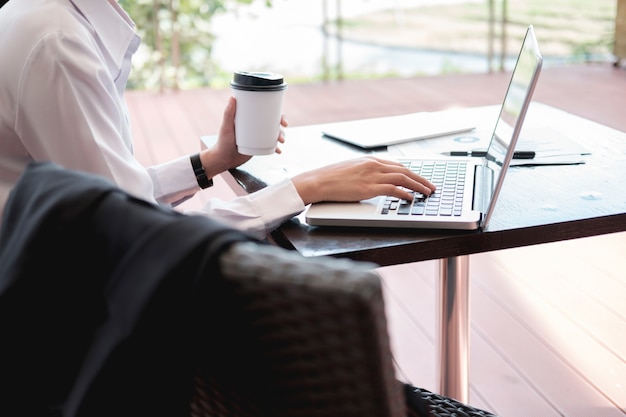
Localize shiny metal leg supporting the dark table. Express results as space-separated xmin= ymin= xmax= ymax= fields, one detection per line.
xmin=439 ymin=255 xmax=469 ymax=403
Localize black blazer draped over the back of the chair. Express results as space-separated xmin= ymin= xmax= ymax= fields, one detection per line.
xmin=0 ymin=163 xmax=253 ymax=417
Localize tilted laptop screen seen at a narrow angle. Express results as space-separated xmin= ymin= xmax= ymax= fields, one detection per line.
xmin=483 ymin=26 xmax=543 ymax=223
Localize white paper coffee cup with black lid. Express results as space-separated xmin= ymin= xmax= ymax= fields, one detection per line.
xmin=230 ymin=71 xmax=287 ymax=155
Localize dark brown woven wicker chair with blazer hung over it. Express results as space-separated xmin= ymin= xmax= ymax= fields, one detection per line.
xmin=192 ymin=243 xmax=493 ymax=417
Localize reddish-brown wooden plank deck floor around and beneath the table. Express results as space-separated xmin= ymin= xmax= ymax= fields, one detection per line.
xmin=127 ymin=64 xmax=626 ymax=417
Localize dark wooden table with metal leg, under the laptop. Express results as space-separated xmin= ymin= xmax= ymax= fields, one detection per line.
xmin=207 ymin=103 xmax=626 ymax=402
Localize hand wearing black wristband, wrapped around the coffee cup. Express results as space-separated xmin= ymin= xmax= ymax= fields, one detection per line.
xmin=200 ymin=97 xmax=288 ymax=177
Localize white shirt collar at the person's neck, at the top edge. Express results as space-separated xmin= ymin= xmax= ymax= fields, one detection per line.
xmin=70 ymin=0 xmax=139 ymax=67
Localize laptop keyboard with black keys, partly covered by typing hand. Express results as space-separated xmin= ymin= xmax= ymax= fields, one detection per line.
xmin=382 ymin=161 xmax=467 ymax=216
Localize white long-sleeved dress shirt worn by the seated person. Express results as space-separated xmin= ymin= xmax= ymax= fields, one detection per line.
xmin=0 ymin=0 xmax=304 ymax=237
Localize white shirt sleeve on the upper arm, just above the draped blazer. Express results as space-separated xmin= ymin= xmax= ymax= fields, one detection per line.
xmin=15 ymin=32 xmax=154 ymax=201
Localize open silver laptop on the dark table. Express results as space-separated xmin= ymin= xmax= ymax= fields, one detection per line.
xmin=305 ymin=26 xmax=543 ymax=230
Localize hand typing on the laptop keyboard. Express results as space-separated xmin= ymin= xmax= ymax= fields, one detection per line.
xmin=292 ymin=157 xmax=435 ymax=204
